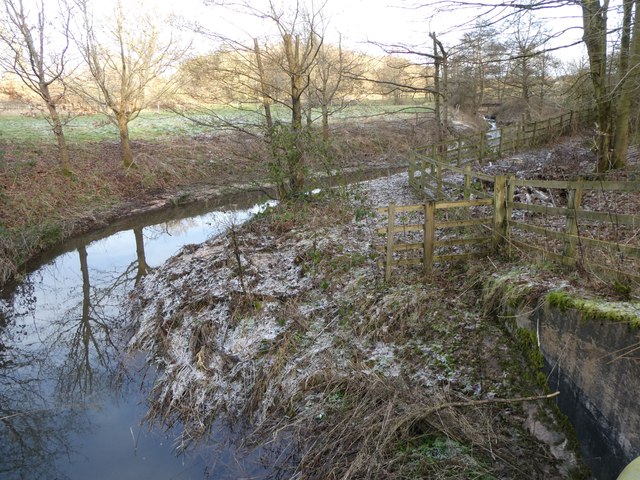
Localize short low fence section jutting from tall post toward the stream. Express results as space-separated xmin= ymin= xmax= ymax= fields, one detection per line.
xmin=378 ymin=199 xmax=497 ymax=282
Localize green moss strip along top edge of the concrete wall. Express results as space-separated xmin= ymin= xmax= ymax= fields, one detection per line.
xmin=546 ymin=291 xmax=640 ymax=328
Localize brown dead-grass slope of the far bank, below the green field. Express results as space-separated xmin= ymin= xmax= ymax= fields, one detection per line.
xmin=0 ymin=120 xmax=436 ymax=285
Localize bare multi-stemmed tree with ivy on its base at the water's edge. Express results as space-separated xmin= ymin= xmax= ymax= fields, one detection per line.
xmin=175 ymin=0 xmax=324 ymax=198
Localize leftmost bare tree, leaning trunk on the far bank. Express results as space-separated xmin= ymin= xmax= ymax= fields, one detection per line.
xmin=0 ymin=0 xmax=71 ymax=175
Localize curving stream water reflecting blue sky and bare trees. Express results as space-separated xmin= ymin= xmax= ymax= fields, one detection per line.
xmin=0 ymin=169 xmax=400 ymax=480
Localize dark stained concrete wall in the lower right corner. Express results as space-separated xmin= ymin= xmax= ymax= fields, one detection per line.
xmin=516 ymin=303 xmax=640 ymax=480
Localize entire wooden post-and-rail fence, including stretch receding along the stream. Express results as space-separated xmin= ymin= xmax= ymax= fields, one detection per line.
xmin=378 ymin=107 xmax=640 ymax=286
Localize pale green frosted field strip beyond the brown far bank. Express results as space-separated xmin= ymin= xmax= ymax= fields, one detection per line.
xmin=0 ymin=104 xmax=430 ymax=144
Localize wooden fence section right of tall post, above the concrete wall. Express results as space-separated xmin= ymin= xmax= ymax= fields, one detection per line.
xmin=494 ymin=176 xmax=640 ymax=283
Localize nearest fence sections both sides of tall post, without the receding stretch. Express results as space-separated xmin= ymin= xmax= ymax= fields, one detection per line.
xmin=378 ymin=177 xmax=640 ymax=285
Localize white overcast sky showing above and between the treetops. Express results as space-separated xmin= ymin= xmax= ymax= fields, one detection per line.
xmin=86 ymin=0 xmax=581 ymax=55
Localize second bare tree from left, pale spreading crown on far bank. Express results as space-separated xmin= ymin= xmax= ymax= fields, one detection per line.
xmin=77 ymin=0 xmax=185 ymax=168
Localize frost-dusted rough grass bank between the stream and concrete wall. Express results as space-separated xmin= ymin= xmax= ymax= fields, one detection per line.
xmin=130 ymin=174 xmax=588 ymax=479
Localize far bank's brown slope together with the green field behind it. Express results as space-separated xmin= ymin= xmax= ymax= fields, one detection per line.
xmin=0 ymin=99 xmax=438 ymax=284
